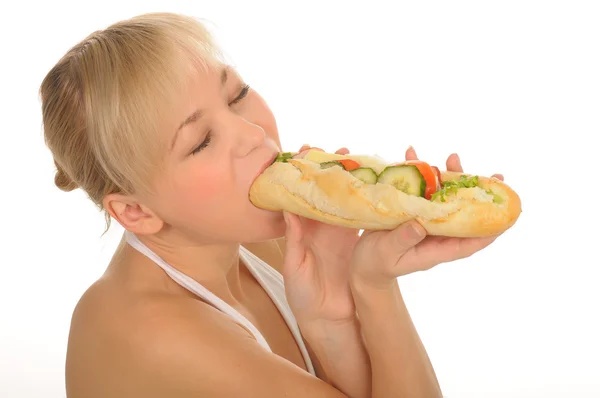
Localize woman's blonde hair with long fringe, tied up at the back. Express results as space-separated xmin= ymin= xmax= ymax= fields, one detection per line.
xmin=40 ymin=13 xmax=223 ymax=232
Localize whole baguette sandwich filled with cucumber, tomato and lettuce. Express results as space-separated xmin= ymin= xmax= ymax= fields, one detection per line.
xmin=249 ymin=150 xmax=521 ymax=237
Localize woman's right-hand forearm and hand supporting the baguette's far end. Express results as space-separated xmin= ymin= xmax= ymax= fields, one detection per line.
xmin=350 ymin=215 xmax=496 ymax=398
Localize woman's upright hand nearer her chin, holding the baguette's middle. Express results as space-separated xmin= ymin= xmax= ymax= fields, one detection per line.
xmin=282 ymin=145 xmax=359 ymax=324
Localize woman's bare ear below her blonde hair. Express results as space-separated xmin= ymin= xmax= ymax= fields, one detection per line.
xmin=103 ymin=193 xmax=164 ymax=235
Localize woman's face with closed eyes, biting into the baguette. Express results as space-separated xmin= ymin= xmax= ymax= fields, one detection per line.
xmin=145 ymin=66 xmax=285 ymax=243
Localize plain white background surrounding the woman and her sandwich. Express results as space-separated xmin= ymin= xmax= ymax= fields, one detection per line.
xmin=0 ymin=0 xmax=600 ymax=398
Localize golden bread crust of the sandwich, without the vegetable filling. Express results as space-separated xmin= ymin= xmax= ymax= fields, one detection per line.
xmin=249 ymin=155 xmax=522 ymax=237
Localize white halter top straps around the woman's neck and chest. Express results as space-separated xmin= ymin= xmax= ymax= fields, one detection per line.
xmin=125 ymin=231 xmax=316 ymax=376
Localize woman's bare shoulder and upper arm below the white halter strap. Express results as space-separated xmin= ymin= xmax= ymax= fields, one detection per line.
xmin=67 ymin=276 xmax=344 ymax=398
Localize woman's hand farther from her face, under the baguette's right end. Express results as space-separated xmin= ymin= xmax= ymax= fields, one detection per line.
xmin=351 ymin=147 xmax=504 ymax=288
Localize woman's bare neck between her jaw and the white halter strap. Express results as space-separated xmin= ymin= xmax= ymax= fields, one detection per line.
xmin=129 ymin=230 xmax=243 ymax=302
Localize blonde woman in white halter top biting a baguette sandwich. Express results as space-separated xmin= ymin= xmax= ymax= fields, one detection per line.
xmin=41 ymin=13 xmax=504 ymax=398
